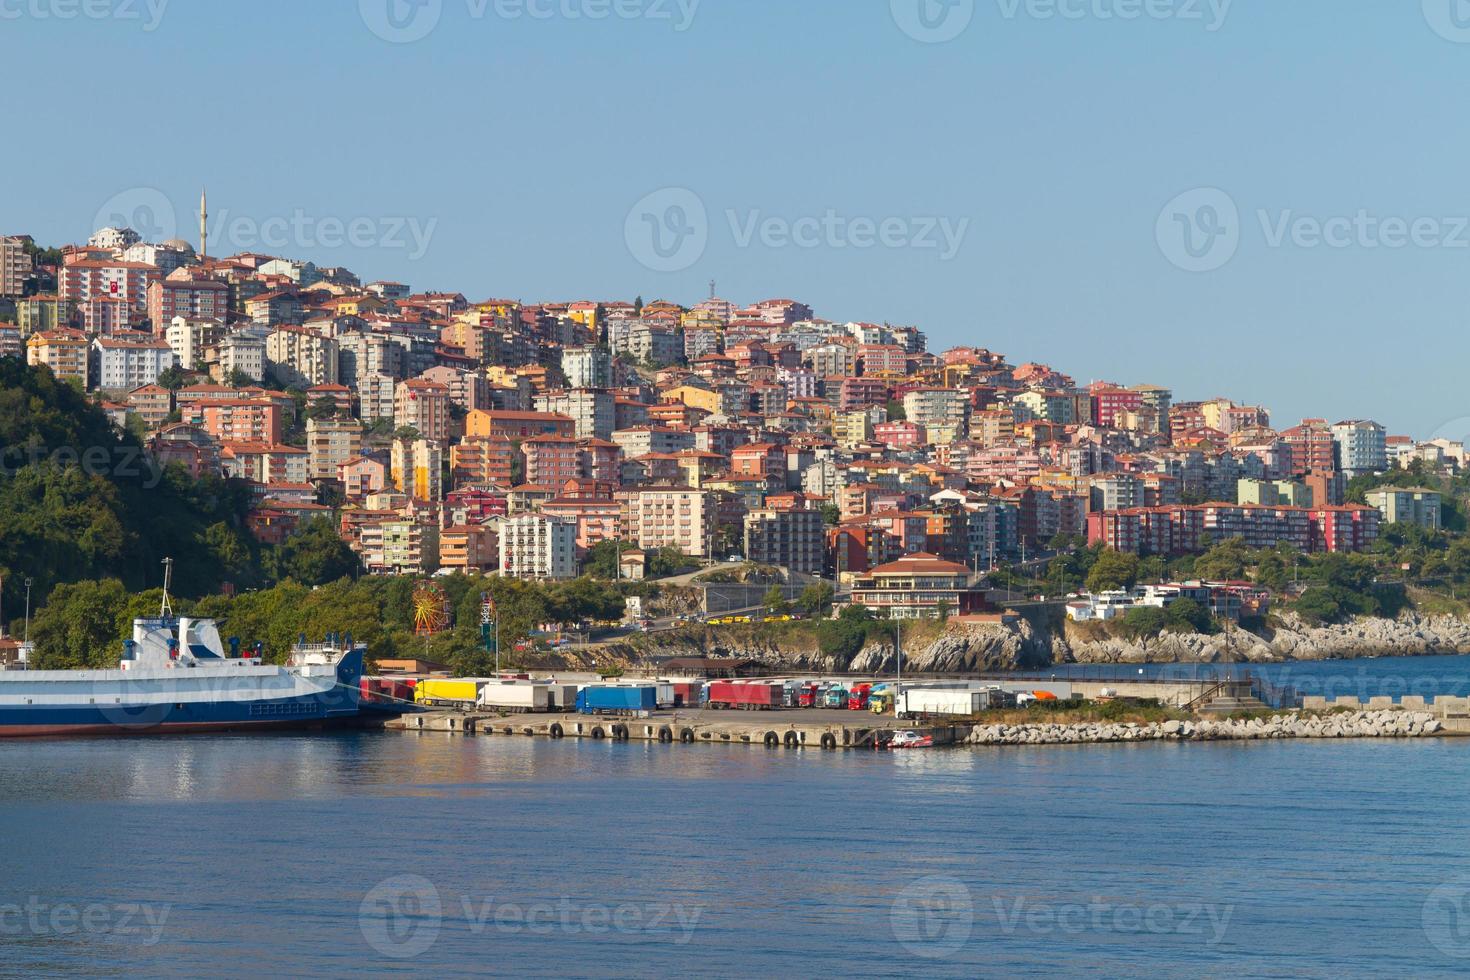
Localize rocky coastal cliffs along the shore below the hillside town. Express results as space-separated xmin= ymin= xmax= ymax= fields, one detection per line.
xmin=579 ymin=613 xmax=1470 ymax=674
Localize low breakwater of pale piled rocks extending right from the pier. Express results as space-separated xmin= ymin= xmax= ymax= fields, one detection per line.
xmin=966 ymin=711 xmax=1444 ymax=745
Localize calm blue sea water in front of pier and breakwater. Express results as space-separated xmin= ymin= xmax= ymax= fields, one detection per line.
xmin=0 ymin=658 xmax=1470 ymax=977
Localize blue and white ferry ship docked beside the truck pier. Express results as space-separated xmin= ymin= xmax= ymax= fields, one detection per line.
xmin=0 ymin=560 xmax=398 ymax=738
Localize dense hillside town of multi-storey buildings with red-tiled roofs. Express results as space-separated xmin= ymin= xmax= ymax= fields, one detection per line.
xmin=0 ymin=221 xmax=1446 ymax=617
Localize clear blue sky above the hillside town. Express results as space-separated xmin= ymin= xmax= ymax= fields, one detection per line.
xmin=11 ymin=0 xmax=1470 ymax=436
